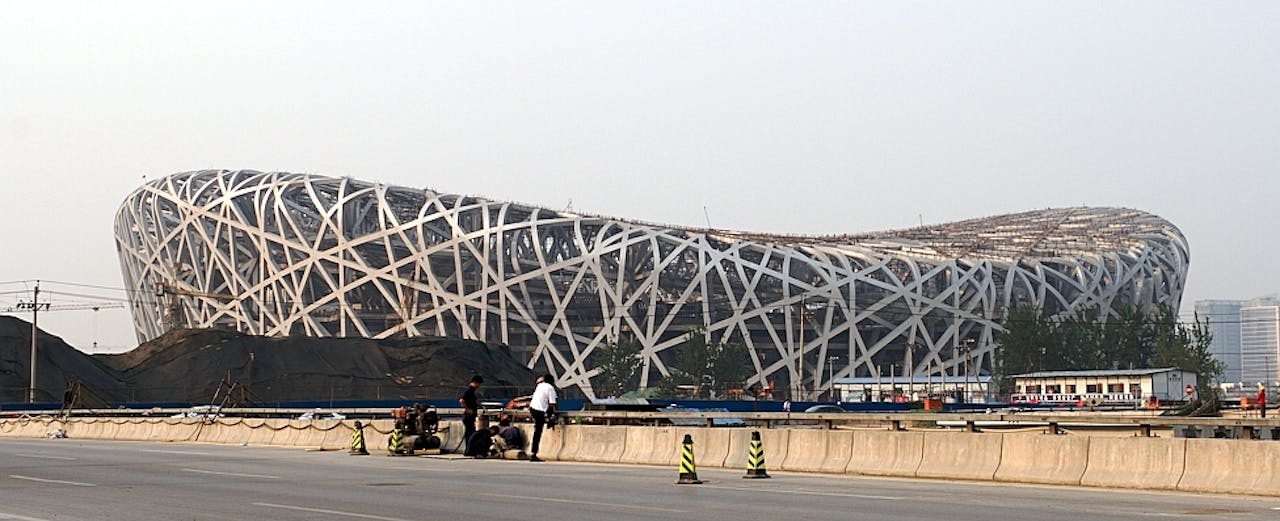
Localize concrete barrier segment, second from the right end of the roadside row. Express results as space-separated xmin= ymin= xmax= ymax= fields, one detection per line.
xmin=1080 ymin=437 xmax=1177 ymax=490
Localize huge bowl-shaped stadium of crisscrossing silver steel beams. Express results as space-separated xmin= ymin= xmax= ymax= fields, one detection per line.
xmin=115 ymin=170 xmax=1189 ymax=396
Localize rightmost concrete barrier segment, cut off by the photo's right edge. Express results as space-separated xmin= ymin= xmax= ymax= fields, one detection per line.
xmin=1178 ymin=439 xmax=1280 ymax=497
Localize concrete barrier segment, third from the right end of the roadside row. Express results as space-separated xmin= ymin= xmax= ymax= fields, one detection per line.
xmin=996 ymin=433 xmax=1089 ymax=485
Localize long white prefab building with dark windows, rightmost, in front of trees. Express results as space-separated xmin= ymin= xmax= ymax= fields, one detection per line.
xmin=1010 ymin=367 xmax=1196 ymax=403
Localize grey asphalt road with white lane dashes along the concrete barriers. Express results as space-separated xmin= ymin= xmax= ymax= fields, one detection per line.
xmin=0 ymin=438 xmax=1280 ymax=521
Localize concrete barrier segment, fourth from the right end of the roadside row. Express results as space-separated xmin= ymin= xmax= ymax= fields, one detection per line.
xmin=915 ymin=433 xmax=1004 ymax=481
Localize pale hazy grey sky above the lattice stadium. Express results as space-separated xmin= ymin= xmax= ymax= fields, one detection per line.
xmin=0 ymin=0 xmax=1280 ymax=352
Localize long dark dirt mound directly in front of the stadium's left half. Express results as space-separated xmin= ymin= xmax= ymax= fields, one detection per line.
xmin=102 ymin=329 xmax=535 ymax=405
